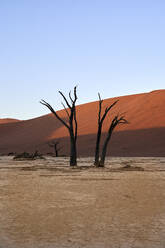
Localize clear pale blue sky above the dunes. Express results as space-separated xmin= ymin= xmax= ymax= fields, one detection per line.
xmin=0 ymin=0 xmax=165 ymax=119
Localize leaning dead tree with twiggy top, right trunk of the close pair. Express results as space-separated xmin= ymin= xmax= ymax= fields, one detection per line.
xmin=99 ymin=115 xmax=128 ymax=167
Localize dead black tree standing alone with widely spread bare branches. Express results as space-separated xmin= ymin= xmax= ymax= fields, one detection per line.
xmin=40 ymin=86 xmax=77 ymax=166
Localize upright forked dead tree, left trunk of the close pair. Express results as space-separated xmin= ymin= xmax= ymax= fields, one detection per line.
xmin=94 ymin=93 xmax=118 ymax=166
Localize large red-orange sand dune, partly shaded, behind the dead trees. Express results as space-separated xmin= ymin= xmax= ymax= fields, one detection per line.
xmin=0 ymin=90 xmax=165 ymax=156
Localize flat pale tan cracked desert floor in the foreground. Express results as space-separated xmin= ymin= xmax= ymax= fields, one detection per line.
xmin=0 ymin=156 xmax=165 ymax=248
